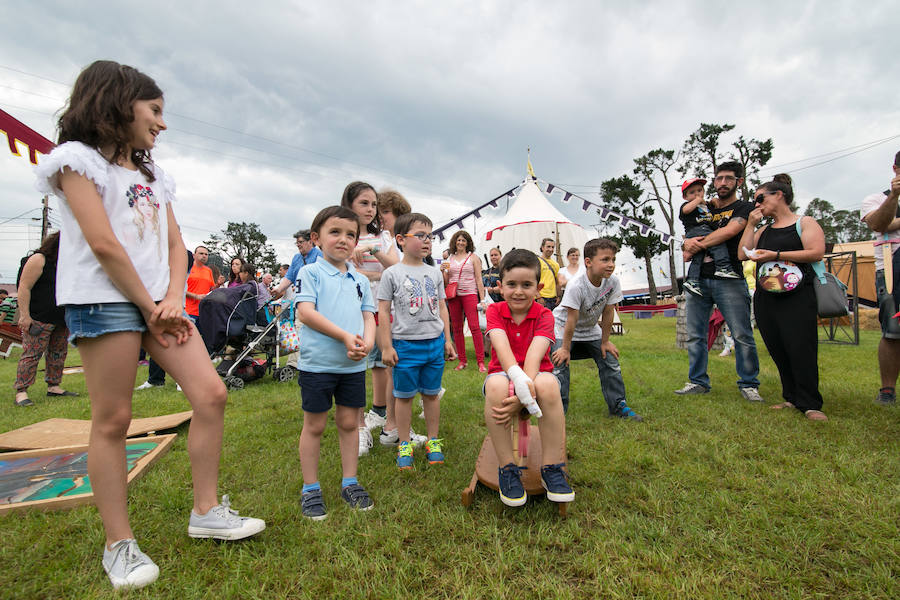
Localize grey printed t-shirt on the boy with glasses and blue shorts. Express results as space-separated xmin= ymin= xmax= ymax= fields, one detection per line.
xmin=376 ymin=262 xmax=445 ymax=340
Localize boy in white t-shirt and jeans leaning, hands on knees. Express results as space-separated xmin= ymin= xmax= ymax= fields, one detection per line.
xmin=550 ymin=238 xmax=641 ymax=421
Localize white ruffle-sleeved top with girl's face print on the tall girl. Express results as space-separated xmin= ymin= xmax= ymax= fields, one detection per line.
xmin=35 ymin=142 xmax=175 ymax=305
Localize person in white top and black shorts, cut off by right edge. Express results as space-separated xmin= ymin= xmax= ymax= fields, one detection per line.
xmin=859 ymin=152 xmax=900 ymax=406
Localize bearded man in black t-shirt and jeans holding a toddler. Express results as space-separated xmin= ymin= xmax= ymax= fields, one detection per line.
xmin=675 ymin=161 xmax=763 ymax=402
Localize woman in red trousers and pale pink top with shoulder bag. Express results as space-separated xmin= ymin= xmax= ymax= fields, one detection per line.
xmin=441 ymin=230 xmax=487 ymax=373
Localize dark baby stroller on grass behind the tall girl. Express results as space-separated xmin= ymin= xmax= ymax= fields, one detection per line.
xmin=197 ymin=284 xmax=296 ymax=390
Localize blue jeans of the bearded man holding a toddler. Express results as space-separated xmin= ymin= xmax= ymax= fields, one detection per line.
xmin=685 ymin=278 xmax=759 ymax=389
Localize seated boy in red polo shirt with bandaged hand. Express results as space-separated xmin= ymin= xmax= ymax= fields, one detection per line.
xmin=483 ymin=249 xmax=575 ymax=506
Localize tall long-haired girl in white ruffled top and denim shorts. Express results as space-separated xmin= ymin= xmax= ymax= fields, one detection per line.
xmin=36 ymin=61 xmax=265 ymax=588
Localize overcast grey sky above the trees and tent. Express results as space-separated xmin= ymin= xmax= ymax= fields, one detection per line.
xmin=0 ymin=0 xmax=900 ymax=285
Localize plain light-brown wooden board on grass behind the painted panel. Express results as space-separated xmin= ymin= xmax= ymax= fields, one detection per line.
xmin=0 ymin=410 xmax=194 ymax=450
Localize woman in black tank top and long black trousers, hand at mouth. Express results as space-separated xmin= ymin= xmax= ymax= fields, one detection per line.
xmin=738 ymin=174 xmax=827 ymax=421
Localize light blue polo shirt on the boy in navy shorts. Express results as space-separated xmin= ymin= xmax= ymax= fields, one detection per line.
xmin=294 ymin=258 xmax=375 ymax=373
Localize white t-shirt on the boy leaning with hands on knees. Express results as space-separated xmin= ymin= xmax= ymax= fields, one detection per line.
xmin=553 ymin=272 xmax=622 ymax=342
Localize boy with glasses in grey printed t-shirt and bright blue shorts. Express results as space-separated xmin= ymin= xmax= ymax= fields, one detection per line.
xmin=377 ymin=213 xmax=456 ymax=470
